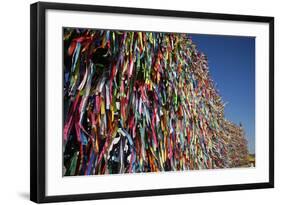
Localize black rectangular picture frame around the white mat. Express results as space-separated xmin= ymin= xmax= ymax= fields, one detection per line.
xmin=30 ymin=2 xmax=274 ymax=203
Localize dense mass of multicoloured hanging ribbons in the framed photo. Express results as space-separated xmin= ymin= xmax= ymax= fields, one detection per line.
xmin=63 ymin=28 xmax=248 ymax=176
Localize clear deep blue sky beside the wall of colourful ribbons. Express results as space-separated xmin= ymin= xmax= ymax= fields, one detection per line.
xmin=190 ymin=34 xmax=255 ymax=153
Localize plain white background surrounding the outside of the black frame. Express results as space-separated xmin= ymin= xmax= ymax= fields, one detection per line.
xmin=0 ymin=0 xmax=276 ymax=205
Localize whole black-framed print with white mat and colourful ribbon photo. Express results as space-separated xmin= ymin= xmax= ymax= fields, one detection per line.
xmin=30 ymin=2 xmax=274 ymax=203
